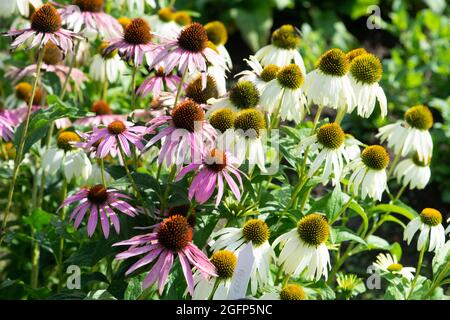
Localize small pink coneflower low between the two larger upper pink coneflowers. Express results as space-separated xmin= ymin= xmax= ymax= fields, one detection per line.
xmin=137 ymin=66 xmax=181 ymax=99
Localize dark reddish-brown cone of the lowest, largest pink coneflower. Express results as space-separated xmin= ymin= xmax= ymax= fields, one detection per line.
xmin=157 ymin=215 xmax=192 ymax=252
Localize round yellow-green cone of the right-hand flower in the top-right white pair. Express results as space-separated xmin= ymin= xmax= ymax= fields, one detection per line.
xmin=350 ymin=53 xmax=383 ymax=84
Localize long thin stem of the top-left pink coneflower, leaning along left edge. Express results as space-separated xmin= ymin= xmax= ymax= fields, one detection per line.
xmin=0 ymin=48 xmax=45 ymax=242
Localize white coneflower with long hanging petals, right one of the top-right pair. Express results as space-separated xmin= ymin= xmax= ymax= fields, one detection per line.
xmin=350 ymin=53 xmax=387 ymax=118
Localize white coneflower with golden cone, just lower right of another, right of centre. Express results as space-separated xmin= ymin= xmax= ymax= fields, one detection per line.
xmin=348 ymin=145 xmax=389 ymax=201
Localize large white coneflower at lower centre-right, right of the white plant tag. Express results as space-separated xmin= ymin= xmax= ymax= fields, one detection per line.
xmin=272 ymin=213 xmax=331 ymax=281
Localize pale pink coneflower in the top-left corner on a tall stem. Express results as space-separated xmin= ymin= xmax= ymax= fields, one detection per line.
xmin=4 ymin=4 xmax=82 ymax=55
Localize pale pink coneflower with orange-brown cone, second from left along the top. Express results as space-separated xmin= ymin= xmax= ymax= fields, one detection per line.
xmin=103 ymin=18 xmax=161 ymax=66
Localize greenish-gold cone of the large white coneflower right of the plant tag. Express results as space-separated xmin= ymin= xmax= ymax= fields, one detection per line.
xmin=297 ymin=213 xmax=330 ymax=247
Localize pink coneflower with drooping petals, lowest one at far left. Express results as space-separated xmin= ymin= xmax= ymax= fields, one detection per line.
xmin=58 ymin=184 xmax=138 ymax=238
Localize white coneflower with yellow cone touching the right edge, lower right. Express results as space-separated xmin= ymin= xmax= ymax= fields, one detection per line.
xmin=403 ymin=208 xmax=445 ymax=252
